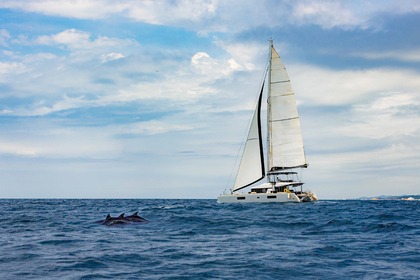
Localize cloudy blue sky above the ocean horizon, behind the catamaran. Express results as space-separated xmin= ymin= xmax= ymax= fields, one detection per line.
xmin=0 ymin=0 xmax=420 ymax=199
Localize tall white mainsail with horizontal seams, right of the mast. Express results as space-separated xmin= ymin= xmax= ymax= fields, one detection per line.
xmin=268 ymin=46 xmax=306 ymax=170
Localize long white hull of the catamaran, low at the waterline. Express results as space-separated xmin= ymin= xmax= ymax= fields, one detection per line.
xmin=217 ymin=192 xmax=301 ymax=203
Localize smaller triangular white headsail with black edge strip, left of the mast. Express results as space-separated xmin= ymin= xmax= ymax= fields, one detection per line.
xmin=232 ymin=84 xmax=265 ymax=191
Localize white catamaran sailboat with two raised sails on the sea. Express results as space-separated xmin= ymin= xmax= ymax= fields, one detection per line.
xmin=217 ymin=40 xmax=318 ymax=203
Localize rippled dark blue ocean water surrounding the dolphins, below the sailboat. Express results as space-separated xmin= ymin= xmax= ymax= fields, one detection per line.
xmin=0 ymin=199 xmax=420 ymax=279
